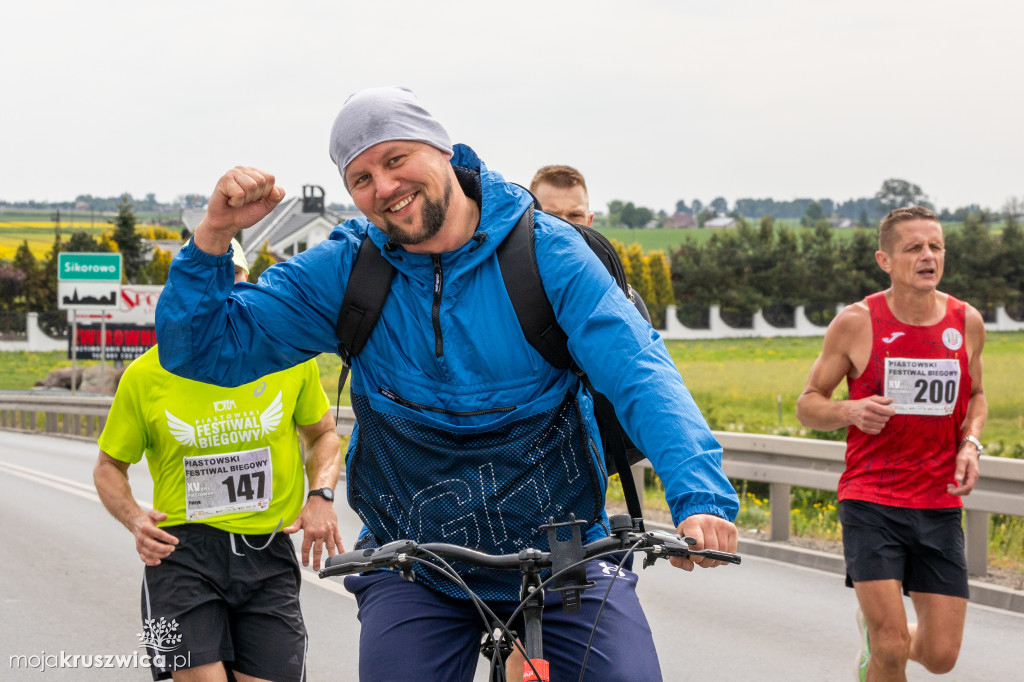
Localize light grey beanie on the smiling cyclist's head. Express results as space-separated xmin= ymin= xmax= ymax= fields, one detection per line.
xmin=331 ymin=87 xmax=452 ymax=179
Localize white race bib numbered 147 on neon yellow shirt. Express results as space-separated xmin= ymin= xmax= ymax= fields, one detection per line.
xmin=184 ymin=447 xmax=273 ymax=521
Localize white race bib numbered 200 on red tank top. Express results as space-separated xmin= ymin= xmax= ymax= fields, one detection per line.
xmin=885 ymin=357 xmax=961 ymax=417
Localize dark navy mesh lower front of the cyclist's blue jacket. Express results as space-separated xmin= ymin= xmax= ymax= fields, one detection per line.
xmin=347 ymin=393 xmax=605 ymax=599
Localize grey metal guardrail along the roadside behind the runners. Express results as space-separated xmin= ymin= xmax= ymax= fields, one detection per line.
xmin=0 ymin=392 xmax=1024 ymax=576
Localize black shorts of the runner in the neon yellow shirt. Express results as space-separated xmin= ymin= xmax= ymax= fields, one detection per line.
xmin=141 ymin=523 xmax=306 ymax=682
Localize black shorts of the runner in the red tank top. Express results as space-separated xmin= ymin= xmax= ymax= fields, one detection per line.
xmin=839 ymin=500 xmax=968 ymax=599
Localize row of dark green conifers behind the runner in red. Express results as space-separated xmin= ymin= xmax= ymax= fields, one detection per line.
xmin=671 ymin=214 xmax=1024 ymax=327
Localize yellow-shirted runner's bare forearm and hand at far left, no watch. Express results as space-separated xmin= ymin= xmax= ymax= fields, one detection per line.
xmin=92 ymin=451 xmax=178 ymax=566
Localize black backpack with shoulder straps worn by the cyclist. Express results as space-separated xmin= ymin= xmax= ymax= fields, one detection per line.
xmin=336 ymin=206 xmax=650 ymax=522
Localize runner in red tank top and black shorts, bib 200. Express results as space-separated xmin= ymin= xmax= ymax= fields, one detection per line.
xmin=797 ymin=206 xmax=988 ymax=682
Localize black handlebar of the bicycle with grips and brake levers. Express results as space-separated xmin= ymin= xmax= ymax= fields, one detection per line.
xmin=318 ymin=522 xmax=740 ymax=579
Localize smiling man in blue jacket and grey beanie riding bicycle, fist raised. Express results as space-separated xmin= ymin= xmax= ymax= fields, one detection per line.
xmin=158 ymin=88 xmax=738 ymax=680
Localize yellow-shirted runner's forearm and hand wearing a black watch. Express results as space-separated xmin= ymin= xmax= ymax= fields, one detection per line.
xmin=285 ymin=411 xmax=345 ymax=570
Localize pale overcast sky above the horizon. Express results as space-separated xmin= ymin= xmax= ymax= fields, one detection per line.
xmin=0 ymin=0 xmax=1024 ymax=213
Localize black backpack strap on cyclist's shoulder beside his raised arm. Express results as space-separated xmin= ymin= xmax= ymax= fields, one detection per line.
xmin=335 ymin=237 xmax=394 ymax=366
